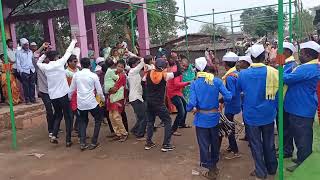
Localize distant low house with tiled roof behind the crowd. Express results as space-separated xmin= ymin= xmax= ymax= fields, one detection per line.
xmin=150 ymin=33 xmax=233 ymax=61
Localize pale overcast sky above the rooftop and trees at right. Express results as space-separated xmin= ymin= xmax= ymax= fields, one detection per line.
xmin=176 ymin=0 xmax=320 ymax=35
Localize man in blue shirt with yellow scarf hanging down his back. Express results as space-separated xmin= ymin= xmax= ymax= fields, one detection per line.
xmin=238 ymin=44 xmax=278 ymax=179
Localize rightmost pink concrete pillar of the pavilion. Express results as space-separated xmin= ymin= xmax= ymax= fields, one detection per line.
xmin=137 ymin=4 xmax=150 ymax=57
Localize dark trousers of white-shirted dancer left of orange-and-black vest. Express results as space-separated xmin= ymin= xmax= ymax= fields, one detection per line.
xmin=130 ymin=99 xmax=147 ymax=137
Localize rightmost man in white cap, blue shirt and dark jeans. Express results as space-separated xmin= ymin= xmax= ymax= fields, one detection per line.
xmin=283 ymin=41 xmax=320 ymax=171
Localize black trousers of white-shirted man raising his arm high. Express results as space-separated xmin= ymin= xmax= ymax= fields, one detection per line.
xmin=51 ymin=94 xmax=72 ymax=142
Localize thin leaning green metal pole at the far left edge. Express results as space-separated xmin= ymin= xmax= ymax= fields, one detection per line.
xmin=0 ymin=1 xmax=17 ymax=149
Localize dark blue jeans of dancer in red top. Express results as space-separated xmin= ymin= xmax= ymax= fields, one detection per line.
xmin=171 ymin=96 xmax=187 ymax=132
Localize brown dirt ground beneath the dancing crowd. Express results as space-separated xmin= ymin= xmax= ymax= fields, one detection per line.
xmin=0 ymin=107 xmax=273 ymax=180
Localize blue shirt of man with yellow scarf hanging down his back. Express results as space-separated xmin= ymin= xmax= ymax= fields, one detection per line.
xmin=238 ymin=67 xmax=277 ymax=126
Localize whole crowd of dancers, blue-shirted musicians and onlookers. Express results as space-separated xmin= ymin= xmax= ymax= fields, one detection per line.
xmin=1 ymin=34 xmax=320 ymax=179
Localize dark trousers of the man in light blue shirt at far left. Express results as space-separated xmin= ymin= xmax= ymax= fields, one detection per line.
xmin=21 ymin=70 xmax=36 ymax=103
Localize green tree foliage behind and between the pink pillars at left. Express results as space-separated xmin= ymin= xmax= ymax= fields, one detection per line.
xmin=12 ymin=0 xmax=180 ymax=50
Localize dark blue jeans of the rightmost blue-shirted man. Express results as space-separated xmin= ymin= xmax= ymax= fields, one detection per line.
xmin=288 ymin=113 xmax=314 ymax=163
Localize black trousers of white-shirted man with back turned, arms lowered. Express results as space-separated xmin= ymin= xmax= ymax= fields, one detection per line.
xmin=78 ymin=105 xmax=102 ymax=144
